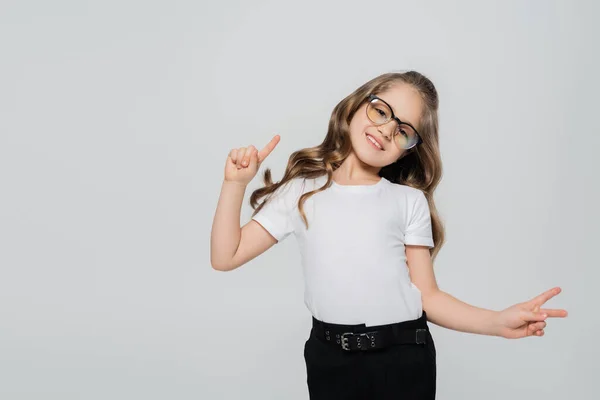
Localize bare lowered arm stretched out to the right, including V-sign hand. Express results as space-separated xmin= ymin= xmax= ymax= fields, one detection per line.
xmin=406 ymin=245 xmax=567 ymax=339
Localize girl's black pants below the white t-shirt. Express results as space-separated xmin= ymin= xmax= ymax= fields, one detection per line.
xmin=304 ymin=312 xmax=436 ymax=400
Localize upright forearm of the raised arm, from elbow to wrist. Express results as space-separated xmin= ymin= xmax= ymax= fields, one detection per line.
xmin=210 ymin=181 xmax=246 ymax=269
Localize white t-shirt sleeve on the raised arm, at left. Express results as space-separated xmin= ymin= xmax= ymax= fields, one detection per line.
xmin=252 ymin=178 xmax=300 ymax=242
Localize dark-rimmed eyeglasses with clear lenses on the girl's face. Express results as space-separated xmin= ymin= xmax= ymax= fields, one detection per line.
xmin=367 ymin=94 xmax=423 ymax=150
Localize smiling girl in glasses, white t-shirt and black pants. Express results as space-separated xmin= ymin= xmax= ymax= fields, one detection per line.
xmin=211 ymin=71 xmax=567 ymax=400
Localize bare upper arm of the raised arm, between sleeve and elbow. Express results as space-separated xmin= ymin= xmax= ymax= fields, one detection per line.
xmin=221 ymin=219 xmax=277 ymax=271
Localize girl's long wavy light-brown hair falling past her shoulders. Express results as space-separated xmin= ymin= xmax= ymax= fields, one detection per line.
xmin=250 ymin=71 xmax=445 ymax=260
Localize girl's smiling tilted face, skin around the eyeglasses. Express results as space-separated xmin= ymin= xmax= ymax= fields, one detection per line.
xmin=350 ymin=83 xmax=423 ymax=167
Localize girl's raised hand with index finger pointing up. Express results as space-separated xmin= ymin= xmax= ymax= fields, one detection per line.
xmin=225 ymin=135 xmax=280 ymax=185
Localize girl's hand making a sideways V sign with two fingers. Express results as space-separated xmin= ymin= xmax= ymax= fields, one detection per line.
xmin=496 ymin=287 xmax=567 ymax=339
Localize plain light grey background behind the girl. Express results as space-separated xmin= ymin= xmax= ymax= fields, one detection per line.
xmin=0 ymin=0 xmax=600 ymax=400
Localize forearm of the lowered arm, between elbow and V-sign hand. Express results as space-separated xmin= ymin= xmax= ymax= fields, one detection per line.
xmin=423 ymin=290 xmax=498 ymax=336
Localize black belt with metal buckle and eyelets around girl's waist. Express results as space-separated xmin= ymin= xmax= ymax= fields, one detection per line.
xmin=312 ymin=311 xmax=429 ymax=351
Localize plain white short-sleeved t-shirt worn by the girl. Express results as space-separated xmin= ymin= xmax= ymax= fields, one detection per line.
xmin=253 ymin=175 xmax=433 ymax=326
